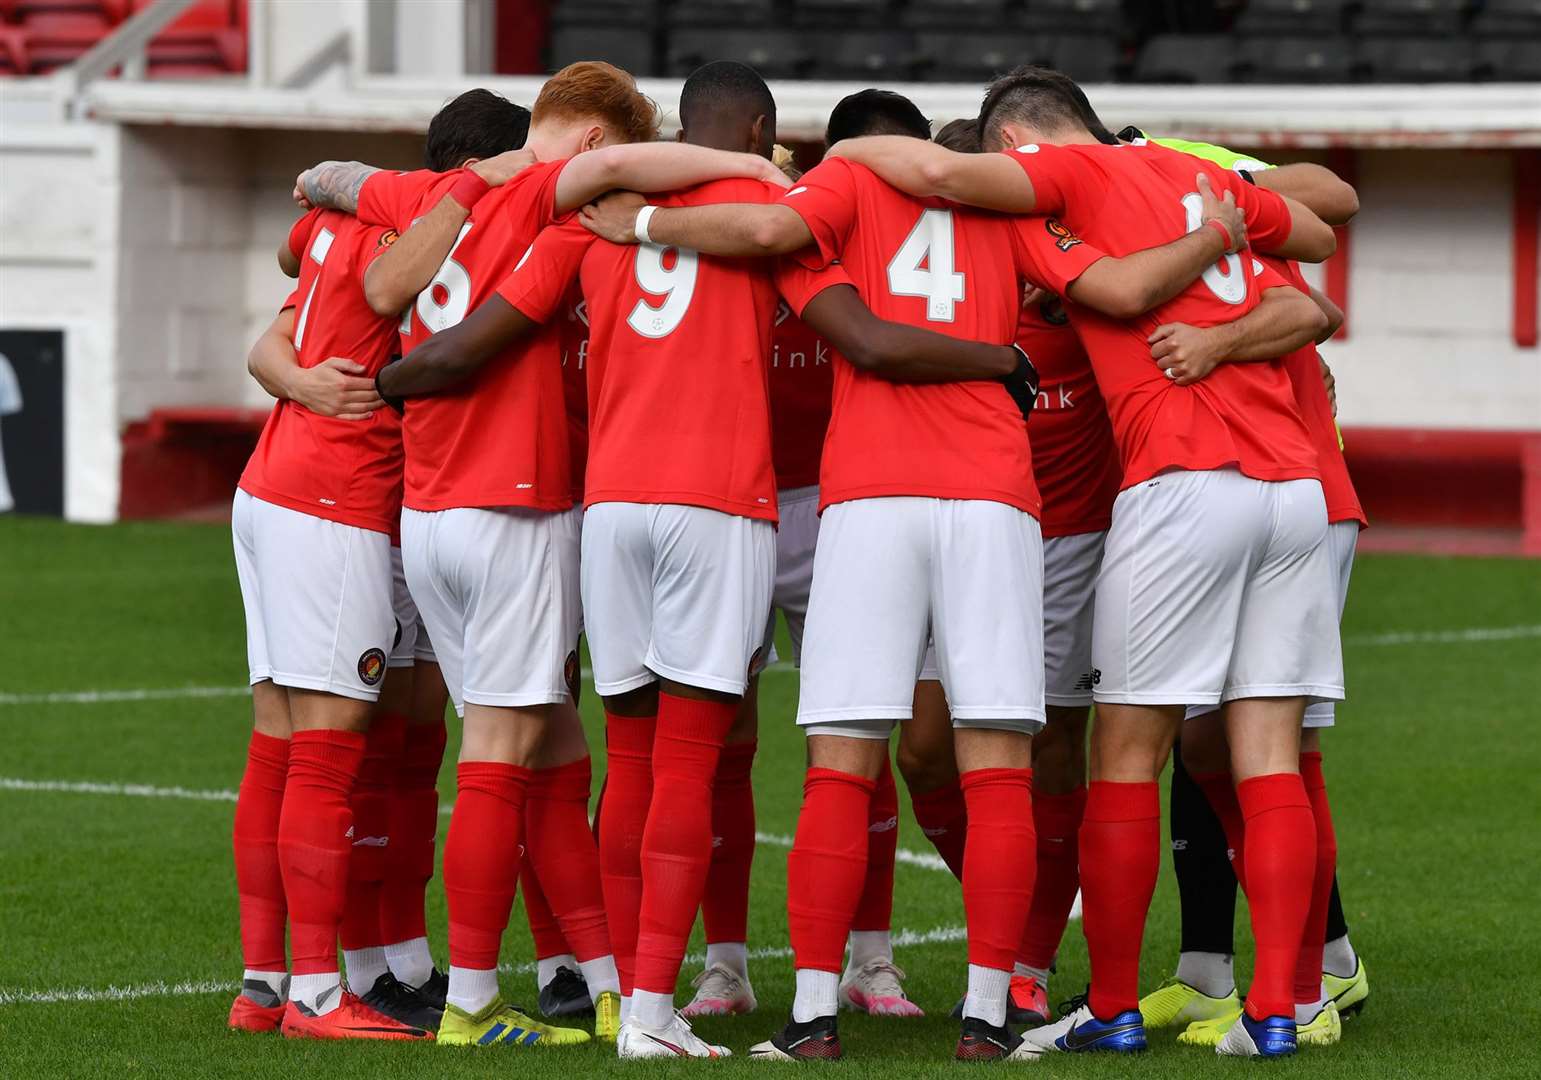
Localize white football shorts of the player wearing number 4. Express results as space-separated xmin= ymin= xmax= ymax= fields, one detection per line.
xmin=797 ymin=498 xmax=1043 ymax=738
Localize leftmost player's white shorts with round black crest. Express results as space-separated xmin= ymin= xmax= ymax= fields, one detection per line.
xmin=231 ymin=490 xmax=393 ymax=701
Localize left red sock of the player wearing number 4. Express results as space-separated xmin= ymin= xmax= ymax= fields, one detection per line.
xmin=786 ymin=769 xmax=877 ymax=974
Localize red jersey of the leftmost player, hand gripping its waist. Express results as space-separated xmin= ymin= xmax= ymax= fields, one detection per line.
xmin=240 ymin=210 xmax=402 ymax=533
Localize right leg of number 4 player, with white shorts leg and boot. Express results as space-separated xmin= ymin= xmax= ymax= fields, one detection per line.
xmin=929 ymin=501 xmax=1045 ymax=1060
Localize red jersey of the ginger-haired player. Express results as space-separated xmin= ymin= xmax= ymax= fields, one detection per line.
xmin=359 ymin=162 xmax=573 ymax=510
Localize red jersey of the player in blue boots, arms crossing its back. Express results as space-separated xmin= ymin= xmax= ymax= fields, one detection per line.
xmin=1008 ymin=143 xmax=1318 ymax=487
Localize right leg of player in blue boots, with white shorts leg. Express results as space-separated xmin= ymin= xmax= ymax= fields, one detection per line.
xmin=1217 ymin=481 xmax=1342 ymax=1057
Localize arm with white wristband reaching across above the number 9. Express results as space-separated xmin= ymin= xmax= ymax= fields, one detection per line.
xmin=582 ymin=189 xmax=819 ymax=256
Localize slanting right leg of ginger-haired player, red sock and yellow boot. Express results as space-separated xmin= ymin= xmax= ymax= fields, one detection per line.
xmin=525 ymin=696 xmax=621 ymax=1038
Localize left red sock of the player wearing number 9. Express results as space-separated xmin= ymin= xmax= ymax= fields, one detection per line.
xmin=599 ymin=712 xmax=658 ymax=995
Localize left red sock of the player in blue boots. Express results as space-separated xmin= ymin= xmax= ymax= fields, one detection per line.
xmin=1080 ymin=780 xmax=1160 ymax=1020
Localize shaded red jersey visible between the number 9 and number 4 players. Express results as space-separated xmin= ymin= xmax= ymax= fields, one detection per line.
xmin=771 ymin=285 xmax=851 ymax=491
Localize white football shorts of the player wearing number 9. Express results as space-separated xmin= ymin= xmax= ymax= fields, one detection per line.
xmin=582 ymin=502 xmax=775 ymax=696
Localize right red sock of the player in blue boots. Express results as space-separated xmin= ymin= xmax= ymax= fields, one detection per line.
xmin=1236 ymin=772 xmax=1321 ymax=1020
